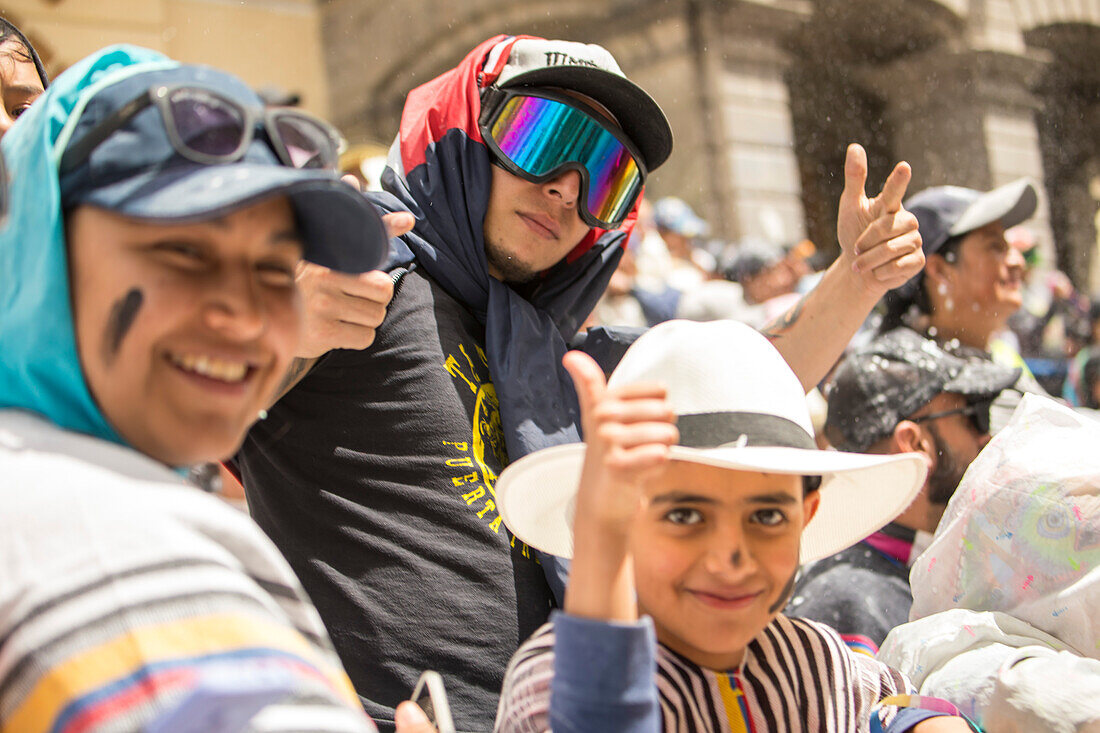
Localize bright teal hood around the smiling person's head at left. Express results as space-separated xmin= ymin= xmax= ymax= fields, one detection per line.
xmin=0 ymin=46 xmax=178 ymax=445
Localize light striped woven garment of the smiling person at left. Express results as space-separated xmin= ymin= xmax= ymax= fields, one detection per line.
xmin=0 ymin=411 xmax=375 ymax=733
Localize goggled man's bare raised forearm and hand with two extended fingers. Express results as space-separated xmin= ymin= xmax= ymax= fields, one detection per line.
xmin=762 ymin=143 xmax=924 ymax=391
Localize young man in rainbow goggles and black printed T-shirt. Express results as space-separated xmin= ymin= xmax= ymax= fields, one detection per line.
xmin=238 ymin=36 xmax=923 ymax=730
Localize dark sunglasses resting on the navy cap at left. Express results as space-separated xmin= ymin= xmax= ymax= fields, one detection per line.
xmin=61 ymin=85 xmax=345 ymax=174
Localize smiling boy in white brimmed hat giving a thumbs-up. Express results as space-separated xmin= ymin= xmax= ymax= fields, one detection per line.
xmin=496 ymin=321 xmax=969 ymax=733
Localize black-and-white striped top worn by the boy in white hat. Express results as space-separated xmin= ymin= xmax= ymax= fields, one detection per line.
xmin=496 ymin=615 xmax=912 ymax=733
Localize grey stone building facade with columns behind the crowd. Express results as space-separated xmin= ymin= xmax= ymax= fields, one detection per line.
xmin=319 ymin=0 xmax=1100 ymax=289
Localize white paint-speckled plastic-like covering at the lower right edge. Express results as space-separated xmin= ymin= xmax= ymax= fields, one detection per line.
xmin=878 ymin=394 xmax=1100 ymax=733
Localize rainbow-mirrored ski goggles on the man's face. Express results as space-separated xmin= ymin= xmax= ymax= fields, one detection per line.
xmin=479 ymin=87 xmax=647 ymax=229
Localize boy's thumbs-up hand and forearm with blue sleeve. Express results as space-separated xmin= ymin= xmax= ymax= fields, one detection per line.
xmin=532 ymin=351 xmax=680 ymax=733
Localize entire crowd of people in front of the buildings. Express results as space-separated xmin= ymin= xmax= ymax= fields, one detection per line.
xmin=0 ymin=15 xmax=1100 ymax=733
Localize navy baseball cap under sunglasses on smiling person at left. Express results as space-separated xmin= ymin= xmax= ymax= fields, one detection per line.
xmin=59 ymin=65 xmax=388 ymax=273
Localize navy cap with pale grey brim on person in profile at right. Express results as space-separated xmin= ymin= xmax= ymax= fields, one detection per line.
xmin=887 ymin=178 xmax=1038 ymax=308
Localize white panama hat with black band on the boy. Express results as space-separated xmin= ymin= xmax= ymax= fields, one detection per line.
xmin=496 ymin=320 xmax=928 ymax=562
